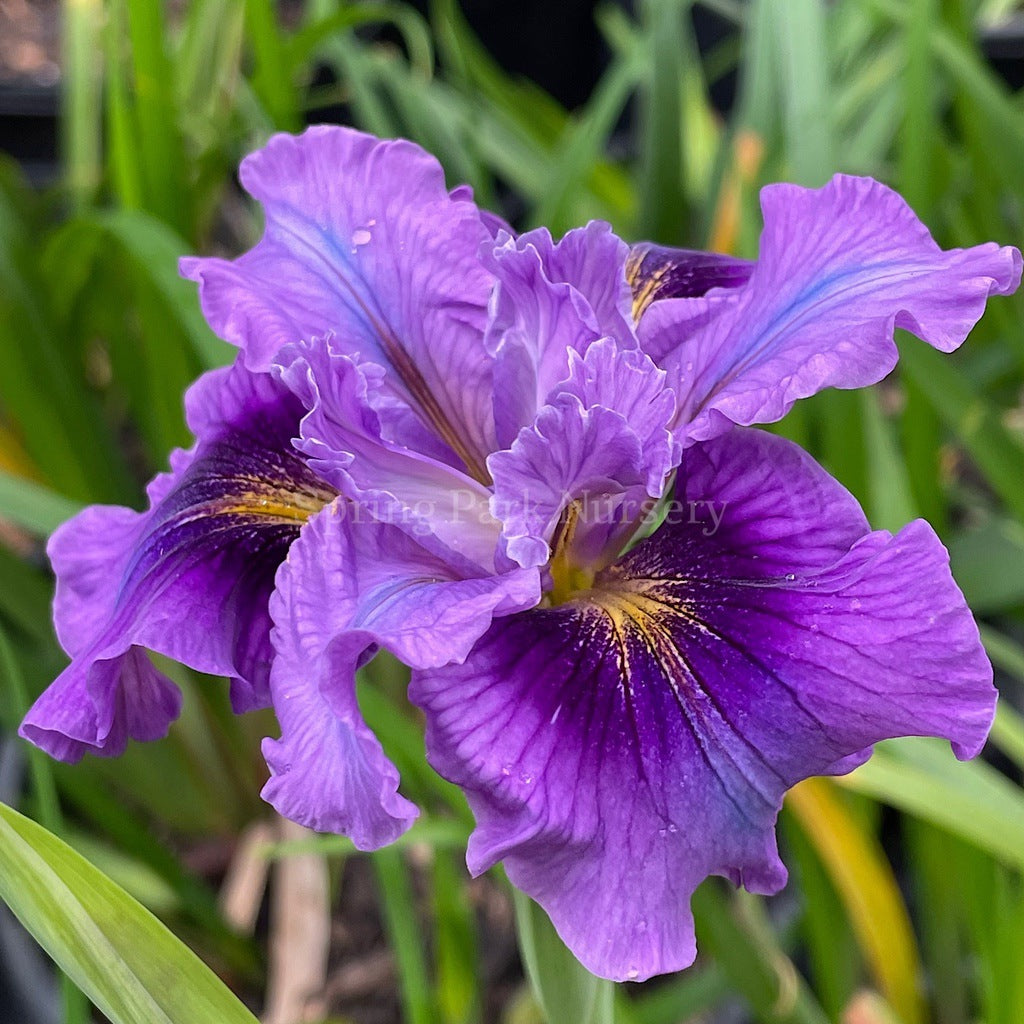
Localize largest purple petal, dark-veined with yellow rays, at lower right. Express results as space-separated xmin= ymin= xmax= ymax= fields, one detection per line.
xmin=411 ymin=429 xmax=995 ymax=979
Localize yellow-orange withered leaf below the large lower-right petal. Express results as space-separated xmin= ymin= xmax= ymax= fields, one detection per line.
xmin=785 ymin=778 xmax=925 ymax=1024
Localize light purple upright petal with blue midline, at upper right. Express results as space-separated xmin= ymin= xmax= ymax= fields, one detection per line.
xmin=639 ymin=175 xmax=1021 ymax=441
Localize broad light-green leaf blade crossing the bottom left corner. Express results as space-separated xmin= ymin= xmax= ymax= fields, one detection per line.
xmin=0 ymin=805 xmax=256 ymax=1024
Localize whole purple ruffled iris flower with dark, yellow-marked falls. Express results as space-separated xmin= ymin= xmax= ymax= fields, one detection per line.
xmin=22 ymin=128 xmax=1021 ymax=979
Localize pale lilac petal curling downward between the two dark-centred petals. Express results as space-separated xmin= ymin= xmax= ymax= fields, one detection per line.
xmin=263 ymin=499 xmax=540 ymax=850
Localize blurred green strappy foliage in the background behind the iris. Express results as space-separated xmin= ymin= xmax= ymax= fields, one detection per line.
xmin=0 ymin=0 xmax=1024 ymax=1024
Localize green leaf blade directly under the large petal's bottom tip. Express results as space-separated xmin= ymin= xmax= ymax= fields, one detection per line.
xmin=512 ymin=889 xmax=615 ymax=1024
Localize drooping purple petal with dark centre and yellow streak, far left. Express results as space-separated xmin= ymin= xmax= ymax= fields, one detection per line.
xmin=22 ymin=364 xmax=335 ymax=760
